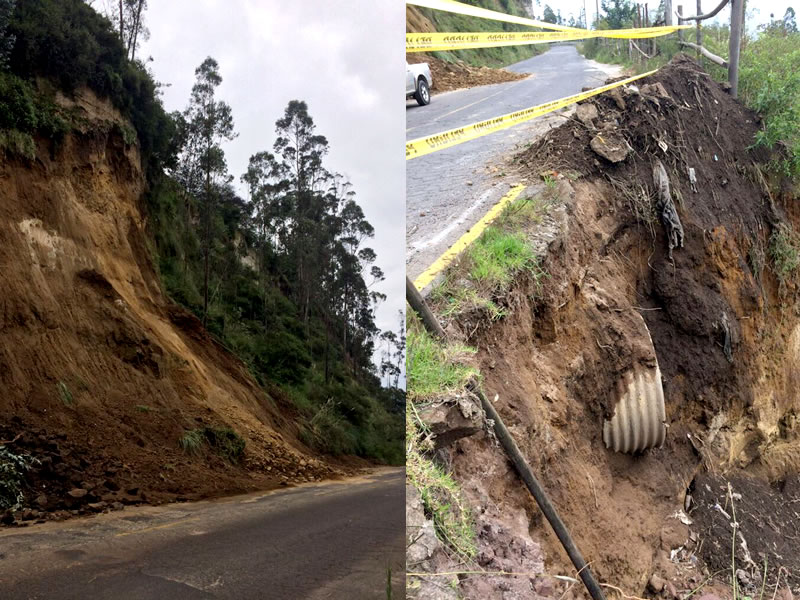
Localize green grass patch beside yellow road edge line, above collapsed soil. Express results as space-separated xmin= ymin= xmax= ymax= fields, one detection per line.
xmin=431 ymin=187 xmax=552 ymax=320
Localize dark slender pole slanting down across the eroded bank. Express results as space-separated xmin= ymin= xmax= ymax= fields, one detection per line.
xmin=406 ymin=286 xmax=605 ymax=600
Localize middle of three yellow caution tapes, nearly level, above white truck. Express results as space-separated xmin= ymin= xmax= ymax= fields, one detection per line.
xmin=406 ymin=27 xmax=678 ymax=52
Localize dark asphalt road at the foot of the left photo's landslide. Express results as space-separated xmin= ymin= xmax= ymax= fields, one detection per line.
xmin=0 ymin=468 xmax=405 ymax=600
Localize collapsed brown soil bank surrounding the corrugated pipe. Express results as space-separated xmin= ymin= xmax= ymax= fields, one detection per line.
xmin=438 ymin=55 xmax=800 ymax=598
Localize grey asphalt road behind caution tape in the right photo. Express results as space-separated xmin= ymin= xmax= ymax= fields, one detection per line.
xmin=406 ymin=45 xmax=619 ymax=280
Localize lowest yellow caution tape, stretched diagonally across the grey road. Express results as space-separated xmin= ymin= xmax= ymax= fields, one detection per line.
xmin=406 ymin=69 xmax=658 ymax=160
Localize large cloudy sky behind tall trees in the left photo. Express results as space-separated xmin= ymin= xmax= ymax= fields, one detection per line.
xmin=138 ymin=0 xmax=405 ymax=370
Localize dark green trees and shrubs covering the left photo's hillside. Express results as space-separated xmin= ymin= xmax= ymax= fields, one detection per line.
xmin=0 ymin=0 xmax=405 ymax=464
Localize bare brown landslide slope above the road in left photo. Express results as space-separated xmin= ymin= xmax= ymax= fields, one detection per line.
xmin=0 ymin=89 xmax=348 ymax=517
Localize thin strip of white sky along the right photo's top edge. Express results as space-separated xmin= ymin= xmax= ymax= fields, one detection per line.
xmin=532 ymin=0 xmax=800 ymax=31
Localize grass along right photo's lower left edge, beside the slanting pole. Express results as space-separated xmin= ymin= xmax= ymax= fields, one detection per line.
xmin=406 ymin=308 xmax=478 ymax=560
